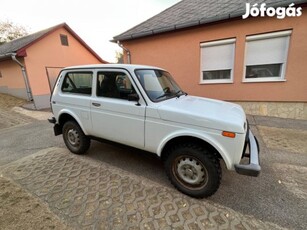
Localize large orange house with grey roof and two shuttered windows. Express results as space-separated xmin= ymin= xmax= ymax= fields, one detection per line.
xmin=114 ymin=0 xmax=307 ymax=119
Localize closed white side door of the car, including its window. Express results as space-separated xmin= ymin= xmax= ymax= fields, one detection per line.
xmin=91 ymin=69 xmax=145 ymax=148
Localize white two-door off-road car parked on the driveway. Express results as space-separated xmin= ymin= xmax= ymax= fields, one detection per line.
xmin=49 ymin=64 xmax=260 ymax=198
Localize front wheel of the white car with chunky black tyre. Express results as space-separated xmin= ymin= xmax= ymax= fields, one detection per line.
xmin=164 ymin=143 xmax=222 ymax=198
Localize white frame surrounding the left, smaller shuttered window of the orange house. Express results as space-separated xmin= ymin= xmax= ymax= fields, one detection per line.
xmin=200 ymin=38 xmax=236 ymax=84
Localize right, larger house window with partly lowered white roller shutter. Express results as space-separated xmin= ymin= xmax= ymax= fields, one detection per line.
xmin=245 ymin=31 xmax=291 ymax=81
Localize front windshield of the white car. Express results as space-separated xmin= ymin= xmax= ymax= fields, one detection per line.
xmin=135 ymin=69 xmax=185 ymax=102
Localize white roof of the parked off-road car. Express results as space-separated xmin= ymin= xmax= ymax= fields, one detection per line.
xmin=63 ymin=64 xmax=162 ymax=71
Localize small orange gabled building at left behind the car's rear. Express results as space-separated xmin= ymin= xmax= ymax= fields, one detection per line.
xmin=0 ymin=23 xmax=106 ymax=109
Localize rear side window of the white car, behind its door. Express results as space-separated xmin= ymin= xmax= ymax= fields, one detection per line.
xmin=62 ymin=72 xmax=93 ymax=95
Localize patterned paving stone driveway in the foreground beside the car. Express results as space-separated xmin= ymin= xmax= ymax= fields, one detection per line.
xmin=1 ymin=148 xmax=280 ymax=229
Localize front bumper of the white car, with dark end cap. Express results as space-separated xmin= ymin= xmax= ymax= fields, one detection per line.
xmin=235 ymin=130 xmax=261 ymax=177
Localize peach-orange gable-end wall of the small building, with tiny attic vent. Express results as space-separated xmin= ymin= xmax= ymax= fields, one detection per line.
xmin=24 ymin=27 xmax=101 ymax=108
